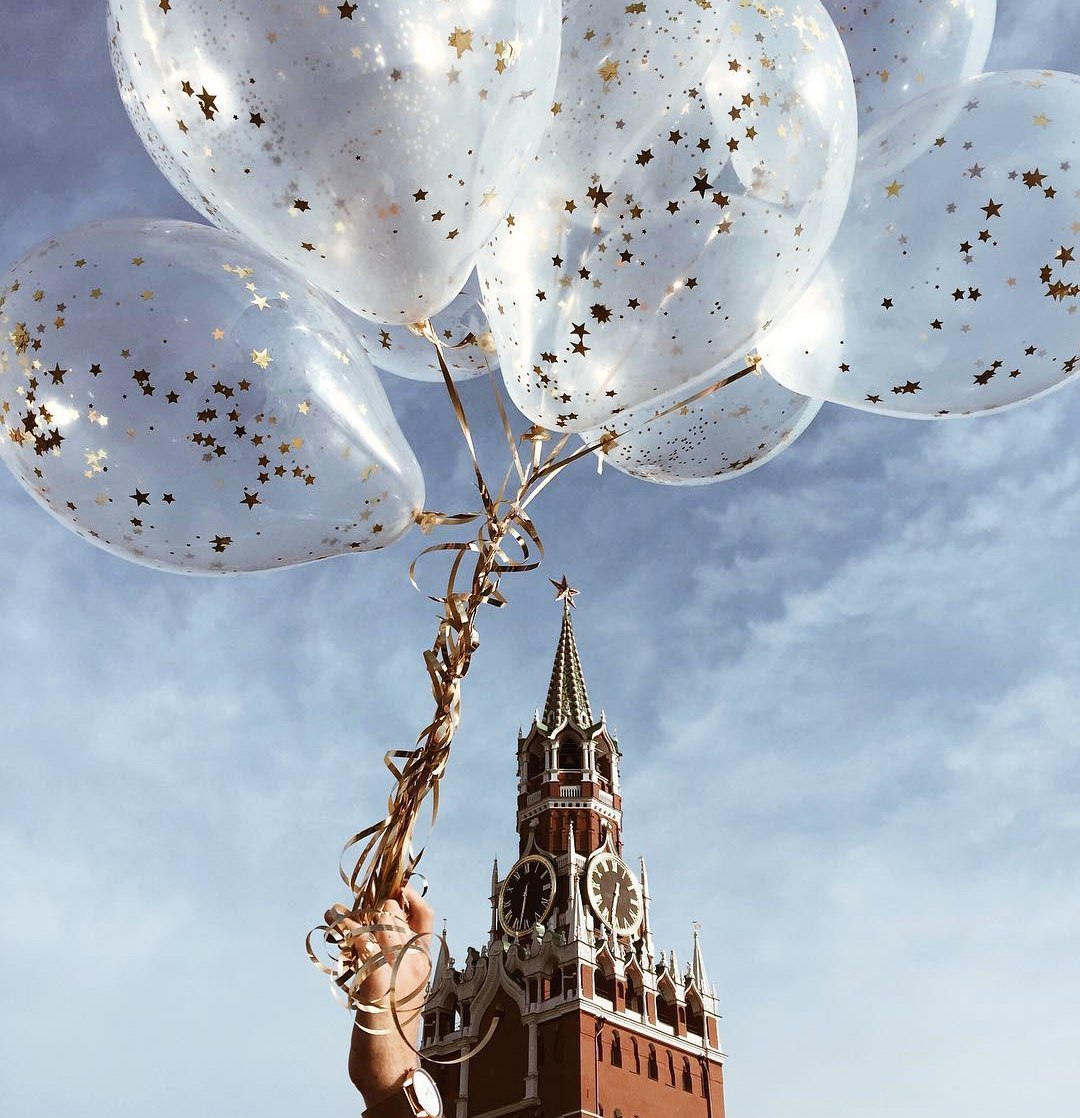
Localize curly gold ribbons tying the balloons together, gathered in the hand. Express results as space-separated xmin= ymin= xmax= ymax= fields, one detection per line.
xmin=306 ymin=322 xmax=760 ymax=1064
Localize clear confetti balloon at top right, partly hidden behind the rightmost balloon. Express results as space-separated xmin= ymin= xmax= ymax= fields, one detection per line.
xmin=822 ymin=0 xmax=997 ymax=130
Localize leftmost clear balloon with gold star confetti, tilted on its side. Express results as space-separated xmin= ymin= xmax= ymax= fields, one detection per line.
xmin=0 ymin=220 xmax=424 ymax=574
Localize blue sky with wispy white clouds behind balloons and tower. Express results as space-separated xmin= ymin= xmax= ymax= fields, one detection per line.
xmin=0 ymin=0 xmax=1080 ymax=1118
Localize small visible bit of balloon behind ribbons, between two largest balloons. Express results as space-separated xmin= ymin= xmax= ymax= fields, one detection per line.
xmin=349 ymin=272 xmax=499 ymax=385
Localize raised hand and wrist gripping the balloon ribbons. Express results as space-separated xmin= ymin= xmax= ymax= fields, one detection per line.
xmin=344 ymin=888 xmax=435 ymax=1107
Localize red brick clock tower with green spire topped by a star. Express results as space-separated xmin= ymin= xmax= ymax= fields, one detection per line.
xmin=421 ymin=578 xmax=724 ymax=1118
